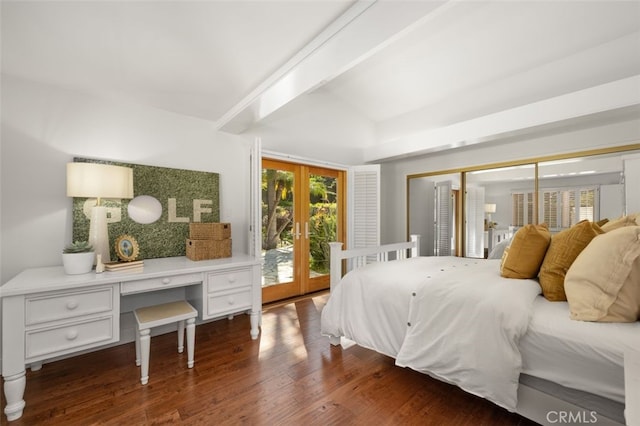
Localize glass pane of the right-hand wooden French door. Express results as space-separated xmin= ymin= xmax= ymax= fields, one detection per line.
xmin=305 ymin=174 xmax=338 ymax=278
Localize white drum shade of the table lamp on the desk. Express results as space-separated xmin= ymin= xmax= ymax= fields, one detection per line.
xmin=67 ymin=163 xmax=133 ymax=199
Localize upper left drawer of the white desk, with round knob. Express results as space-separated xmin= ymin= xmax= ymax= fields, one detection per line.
xmin=25 ymin=286 xmax=119 ymax=326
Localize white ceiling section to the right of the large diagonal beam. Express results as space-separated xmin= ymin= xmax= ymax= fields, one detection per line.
xmin=327 ymin=1 xmax=640 ymax=126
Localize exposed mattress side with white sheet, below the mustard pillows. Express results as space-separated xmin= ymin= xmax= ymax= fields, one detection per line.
xmin=519 ymin=296 xmax=640 ymax=403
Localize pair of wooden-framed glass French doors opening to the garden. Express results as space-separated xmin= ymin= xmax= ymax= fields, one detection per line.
xmin=262 ymin=159 xmax=345 ymax=303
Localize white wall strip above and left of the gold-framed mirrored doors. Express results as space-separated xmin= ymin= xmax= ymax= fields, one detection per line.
xmin=381 ymin=119 xmax=640 ymax=244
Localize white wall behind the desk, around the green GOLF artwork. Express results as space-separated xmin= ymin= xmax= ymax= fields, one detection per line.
xmin=0 ymin=75 xmax=250 ymax=283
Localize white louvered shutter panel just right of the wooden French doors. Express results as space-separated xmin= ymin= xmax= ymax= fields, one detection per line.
xmin=347 ymin=164 xmax=380 ymax=248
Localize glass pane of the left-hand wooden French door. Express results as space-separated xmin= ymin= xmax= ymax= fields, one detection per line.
xmin=262 ymin=168 xmax=295 ymax=287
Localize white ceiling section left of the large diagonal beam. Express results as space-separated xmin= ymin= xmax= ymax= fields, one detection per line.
xmin=2 ymin=1 xmax=348 ymax=121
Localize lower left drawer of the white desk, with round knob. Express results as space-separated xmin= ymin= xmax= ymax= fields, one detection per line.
xmin=25 ymin=315 xmax=120 ymax=361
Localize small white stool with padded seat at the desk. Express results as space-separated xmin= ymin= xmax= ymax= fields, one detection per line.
xmin=133 ymin=300 xmax=198 ymax=385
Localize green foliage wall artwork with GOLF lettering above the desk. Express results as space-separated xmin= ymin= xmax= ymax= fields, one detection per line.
xmin=73 ymin=158 xmax=220 ymax=259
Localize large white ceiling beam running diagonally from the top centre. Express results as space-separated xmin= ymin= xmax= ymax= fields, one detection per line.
xmin=217 ymin=0 xmax=448 ymax=133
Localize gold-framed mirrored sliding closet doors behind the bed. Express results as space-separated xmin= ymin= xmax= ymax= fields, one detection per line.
xmin=408 ymin=146 xmax=640 ymax=258
